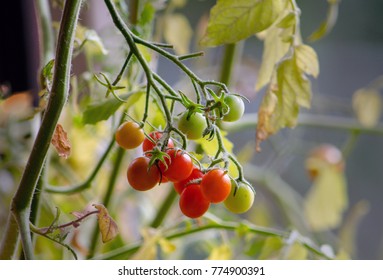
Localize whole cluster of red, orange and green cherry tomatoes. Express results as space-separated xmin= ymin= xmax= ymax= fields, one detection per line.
xmin=115 ymin=96 xmax=254 ymax=218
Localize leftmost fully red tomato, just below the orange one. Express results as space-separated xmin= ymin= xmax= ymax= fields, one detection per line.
xmin=127 ymin=157 xmax=161 ymax=191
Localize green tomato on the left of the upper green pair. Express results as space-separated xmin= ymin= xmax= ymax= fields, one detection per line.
xmin=178 ymin=111 xmax=207 ymax=140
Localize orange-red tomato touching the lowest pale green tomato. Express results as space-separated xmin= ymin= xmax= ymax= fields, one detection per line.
xmin=201 ymin=169 xmax=231 ymax=203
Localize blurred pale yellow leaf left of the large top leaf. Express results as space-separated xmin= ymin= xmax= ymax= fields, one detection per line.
xmin=164 ymin=14 xmax=193 ymax=55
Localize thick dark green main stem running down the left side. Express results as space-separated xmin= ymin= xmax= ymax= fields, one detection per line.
xmin=11 ymin=0 xmax=82 ymax=259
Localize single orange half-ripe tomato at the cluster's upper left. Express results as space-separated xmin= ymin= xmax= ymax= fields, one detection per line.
xmin=115 ymin=121 xmax=145 ymax=149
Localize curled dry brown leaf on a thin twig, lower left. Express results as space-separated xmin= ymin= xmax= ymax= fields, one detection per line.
xmin=93 ymin=204 xmax=118 ymax=243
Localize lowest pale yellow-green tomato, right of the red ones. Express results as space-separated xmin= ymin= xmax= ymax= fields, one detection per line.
xmin=224 ymin=183 xmax=255 ymax=214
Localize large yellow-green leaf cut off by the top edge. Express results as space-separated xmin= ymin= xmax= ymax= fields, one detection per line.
xmin=201 ymin=0 xmax=287 ymax=47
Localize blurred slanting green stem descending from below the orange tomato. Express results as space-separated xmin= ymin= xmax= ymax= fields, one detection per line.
xmin=87 ymin=148 xmax=125 ymax=258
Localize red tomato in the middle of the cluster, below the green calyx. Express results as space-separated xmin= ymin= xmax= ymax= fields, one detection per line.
xmin=159 ymin=149 xmax=193 ymax=182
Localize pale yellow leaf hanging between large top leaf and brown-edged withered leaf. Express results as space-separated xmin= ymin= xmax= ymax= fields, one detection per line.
xmin=255 ymin=27 xmax=290 ymax=90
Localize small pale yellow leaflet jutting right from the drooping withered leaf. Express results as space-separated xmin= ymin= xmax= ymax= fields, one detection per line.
xmin=295 ymin=45 xmax=319 ymax=78
